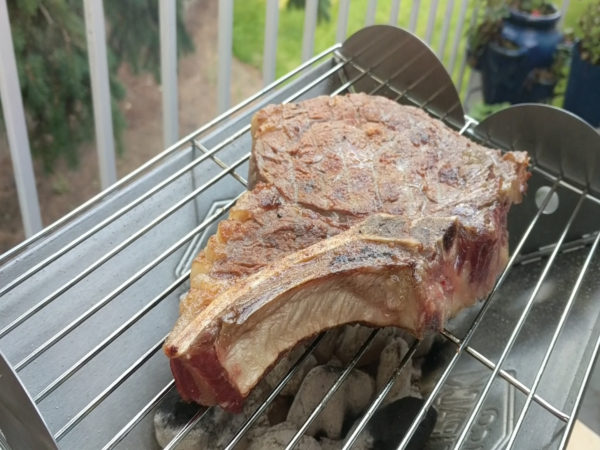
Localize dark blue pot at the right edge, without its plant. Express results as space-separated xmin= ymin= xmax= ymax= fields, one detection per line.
xmin=563 ymin=44 xmax=600 ymax=127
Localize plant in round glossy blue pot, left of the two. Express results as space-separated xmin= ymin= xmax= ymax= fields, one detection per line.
xmin=469 ymin=0 xmax=562 ymax=103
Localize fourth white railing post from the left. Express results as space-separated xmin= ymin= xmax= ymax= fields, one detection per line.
xmin=217 ymin=0 xmax=233 ymax=113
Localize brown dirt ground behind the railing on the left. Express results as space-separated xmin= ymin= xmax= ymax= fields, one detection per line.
xmin=0 ymin=0 xmax=262 ymax=254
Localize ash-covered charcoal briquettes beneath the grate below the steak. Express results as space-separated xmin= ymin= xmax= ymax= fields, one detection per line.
xmin=154 ymin=325 xmax=435 ymax=450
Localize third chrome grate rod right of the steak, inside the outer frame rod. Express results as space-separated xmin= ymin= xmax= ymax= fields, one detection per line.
xmin=506 ymin=233 xmax=600 ymax=448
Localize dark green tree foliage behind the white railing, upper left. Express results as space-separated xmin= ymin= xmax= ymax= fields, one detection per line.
xmin=8 ymin=0 xmax=193 ymax=171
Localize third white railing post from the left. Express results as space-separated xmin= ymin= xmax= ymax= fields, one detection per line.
xmin=158 ymin=0 xmax=179 ymax=148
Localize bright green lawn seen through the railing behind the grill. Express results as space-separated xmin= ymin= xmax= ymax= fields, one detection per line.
xmin=233 ymin=0 xmax=592 ymax=101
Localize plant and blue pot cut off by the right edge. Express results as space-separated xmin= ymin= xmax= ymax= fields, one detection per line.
xmin=564 ymin=0 xmax=600 ymax=127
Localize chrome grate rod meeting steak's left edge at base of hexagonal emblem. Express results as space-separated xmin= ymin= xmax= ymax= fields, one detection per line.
xmin=33 ymin=270 xmax=190 ymax=403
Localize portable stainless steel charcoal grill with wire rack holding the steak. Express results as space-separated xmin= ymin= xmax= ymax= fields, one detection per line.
xmin=0 ymin=26 xmax=600 ymax=449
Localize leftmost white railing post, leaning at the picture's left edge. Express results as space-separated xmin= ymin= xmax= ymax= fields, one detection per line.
xmin=0 ymin=0 xmax=42 ymax=237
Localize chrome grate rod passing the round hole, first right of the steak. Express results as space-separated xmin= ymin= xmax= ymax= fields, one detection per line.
xmin=400 ymin=178 xmax=558 ymax=447
